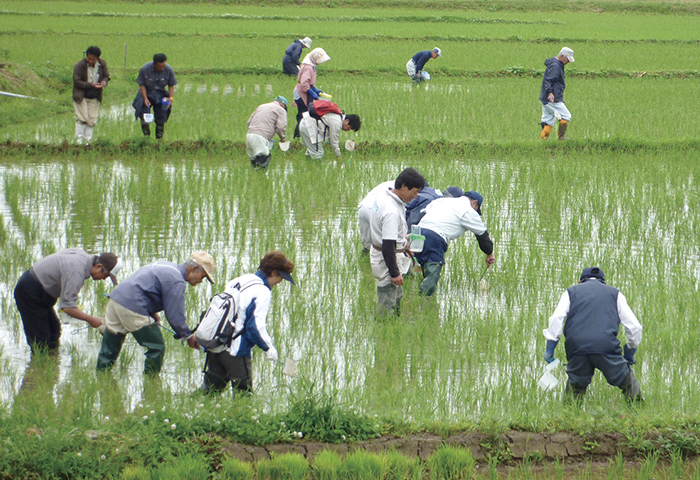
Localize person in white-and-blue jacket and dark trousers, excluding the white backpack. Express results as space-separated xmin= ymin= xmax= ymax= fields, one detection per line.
xmin=196 ymin=250 xmax=296 ymax=393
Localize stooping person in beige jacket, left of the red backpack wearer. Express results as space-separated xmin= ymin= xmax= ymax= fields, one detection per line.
xmin=245 ymin=96 xmax=287 ymax=168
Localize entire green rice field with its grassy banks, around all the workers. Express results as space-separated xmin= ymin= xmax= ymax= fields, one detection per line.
xmin=0 ymin=1 xmax=700 ymax=478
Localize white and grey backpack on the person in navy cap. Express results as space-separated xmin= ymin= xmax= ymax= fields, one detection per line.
xmin=194 ymin=277 xmax=263 ymax=353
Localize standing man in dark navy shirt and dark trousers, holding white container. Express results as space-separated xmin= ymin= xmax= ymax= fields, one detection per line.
xmin=133 ymin=53 xmax=177 ymax=139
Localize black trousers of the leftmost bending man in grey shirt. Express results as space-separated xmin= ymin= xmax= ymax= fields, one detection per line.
xmin=15 ymin=268 xmax=61 ymax=353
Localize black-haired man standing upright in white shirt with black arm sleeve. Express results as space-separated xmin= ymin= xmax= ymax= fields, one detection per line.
xmin=369 ymin=168 xmax=426 ymax=316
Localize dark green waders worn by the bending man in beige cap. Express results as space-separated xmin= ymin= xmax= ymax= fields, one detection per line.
xmin=97 ymin=323 xmax=165 ymax=375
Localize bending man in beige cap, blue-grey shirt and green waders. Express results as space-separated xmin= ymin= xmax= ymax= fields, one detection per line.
xmin=97 ymin=251 xmax=216 ymax=375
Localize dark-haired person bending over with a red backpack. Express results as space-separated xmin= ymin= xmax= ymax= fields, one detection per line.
xmin=299 ymin=100 xmax=362 ymax=161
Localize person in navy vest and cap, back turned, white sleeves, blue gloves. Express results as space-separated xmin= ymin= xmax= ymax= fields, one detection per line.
xmin=542 ymin=267 xmax=643 ymax=401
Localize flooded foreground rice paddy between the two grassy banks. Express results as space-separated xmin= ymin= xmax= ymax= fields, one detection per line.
xmin=0 ymin=150 xmax=700 ymax=424
